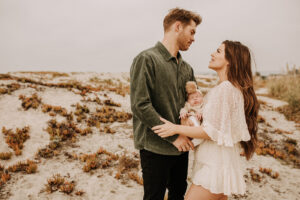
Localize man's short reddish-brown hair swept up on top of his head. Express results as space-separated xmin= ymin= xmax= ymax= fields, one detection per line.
xmin=164 ymin=8 xmax=202 ymax=31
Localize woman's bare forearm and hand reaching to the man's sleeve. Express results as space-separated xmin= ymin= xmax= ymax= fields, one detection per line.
xmin=152 ymin=118 xmax=211 ymax=140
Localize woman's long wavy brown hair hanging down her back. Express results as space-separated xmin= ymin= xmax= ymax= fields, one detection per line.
xmin=223 ymin=40 xmax=259 ymax=160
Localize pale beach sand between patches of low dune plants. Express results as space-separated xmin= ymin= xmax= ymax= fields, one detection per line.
xmin=0 ymin=72 xmax=300 ymax=200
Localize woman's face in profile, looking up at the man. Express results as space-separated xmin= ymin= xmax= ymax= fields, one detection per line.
xmin=208 ymin=44 xmax=229 ymax=71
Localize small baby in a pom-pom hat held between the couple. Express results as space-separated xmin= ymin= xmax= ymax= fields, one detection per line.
xmin=180 ymin=81 xmax=203 ymax=146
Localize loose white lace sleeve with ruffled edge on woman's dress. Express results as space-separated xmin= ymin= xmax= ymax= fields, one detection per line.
xmin=203 ymin=81 xmax=250 ymax=146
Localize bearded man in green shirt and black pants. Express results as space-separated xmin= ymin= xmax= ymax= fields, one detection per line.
xmin=130 ymin=8 xmax=202 ymax=200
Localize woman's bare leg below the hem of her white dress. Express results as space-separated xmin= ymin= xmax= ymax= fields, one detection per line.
xmin=184 ymin=184 xmax=227 ymax=200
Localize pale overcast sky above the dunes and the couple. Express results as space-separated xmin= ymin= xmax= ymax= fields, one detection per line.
xmin=0 ymin=0 xmax=300 ymax=73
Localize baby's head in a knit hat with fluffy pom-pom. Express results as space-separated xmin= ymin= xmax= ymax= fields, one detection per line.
xmin=185 ymin=81 xmax=203 ymax=106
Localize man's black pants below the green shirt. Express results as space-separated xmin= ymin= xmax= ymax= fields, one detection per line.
xmin=140 ymin=149 xmax=189 ymax=200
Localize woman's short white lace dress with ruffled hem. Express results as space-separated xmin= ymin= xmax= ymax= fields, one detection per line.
xmin=192 ymin=81 xmax=250 ymax=195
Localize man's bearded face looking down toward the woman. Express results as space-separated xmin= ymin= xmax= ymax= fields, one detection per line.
xmin=177 ymin=20 xmax=197 ymax=51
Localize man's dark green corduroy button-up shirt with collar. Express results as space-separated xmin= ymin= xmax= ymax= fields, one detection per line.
xmin=130 ymin=42 xmax=195 ymax=155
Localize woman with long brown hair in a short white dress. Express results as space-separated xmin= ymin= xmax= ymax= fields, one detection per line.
xmin=153 ymin=40 xmax=259 ymax=200
